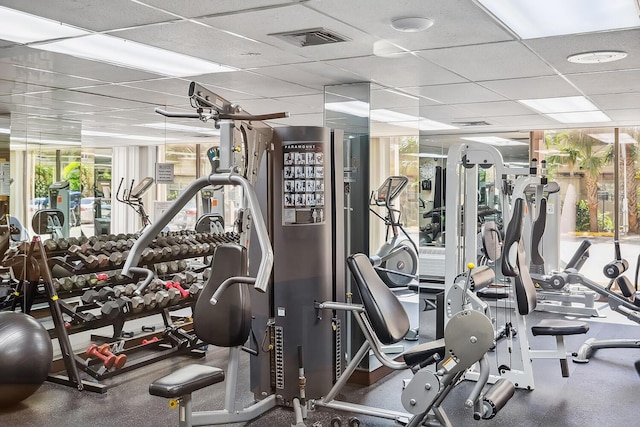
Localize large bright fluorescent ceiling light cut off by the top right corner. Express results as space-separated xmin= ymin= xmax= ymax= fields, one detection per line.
xmin=478 ymin=0 xmax=640 ymax=39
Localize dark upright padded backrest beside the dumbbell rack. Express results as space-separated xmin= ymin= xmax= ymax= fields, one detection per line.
xmin=193 ymin=243 xmax=251 ymax=347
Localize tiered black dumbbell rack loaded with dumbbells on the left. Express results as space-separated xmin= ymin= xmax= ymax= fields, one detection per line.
xmin=5 ymin=232 xmax=238 ymax=392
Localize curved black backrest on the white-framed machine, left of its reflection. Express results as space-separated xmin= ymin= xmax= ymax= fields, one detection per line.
xmin=502 ymin=198 xmax=537 ymax=315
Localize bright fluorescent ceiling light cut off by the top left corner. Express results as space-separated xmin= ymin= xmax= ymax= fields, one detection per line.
xmin=0 ymin=6 xmax=90 ymax=43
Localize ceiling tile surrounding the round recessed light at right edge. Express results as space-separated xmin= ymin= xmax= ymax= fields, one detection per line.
xmin=524 ymin=29 xmax=640 ymax=74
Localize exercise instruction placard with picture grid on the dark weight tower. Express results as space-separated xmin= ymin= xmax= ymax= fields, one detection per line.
xmin=282 ymin=142 xmax=325 ymax=225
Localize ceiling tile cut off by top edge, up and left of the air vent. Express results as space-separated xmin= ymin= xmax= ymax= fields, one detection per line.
xmin=139 ymin=0 xmax=307 ymax=19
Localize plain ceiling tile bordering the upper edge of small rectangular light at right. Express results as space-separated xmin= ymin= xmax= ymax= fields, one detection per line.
xmin=480 ymin=76 xmax=580 ymax=99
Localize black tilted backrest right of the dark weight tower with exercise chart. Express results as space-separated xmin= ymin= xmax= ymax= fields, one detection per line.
xmin=347 ymin=254 xmax=410 ymax=344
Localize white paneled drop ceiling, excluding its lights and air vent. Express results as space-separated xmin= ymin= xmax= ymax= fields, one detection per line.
xmin=0 ymin=0 xmax=640 ymax=146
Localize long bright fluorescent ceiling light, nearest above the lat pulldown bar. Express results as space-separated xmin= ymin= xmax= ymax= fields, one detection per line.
xmin=33 ymin=34 xmax=237 ymax=77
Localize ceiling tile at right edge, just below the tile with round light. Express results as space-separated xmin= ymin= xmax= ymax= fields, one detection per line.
xmin=567 ymin=70 xmax=640 ymax=95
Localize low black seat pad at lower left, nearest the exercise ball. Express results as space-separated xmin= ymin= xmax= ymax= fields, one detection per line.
xmin=149 ymin=365 xmax=224 ymax=399
